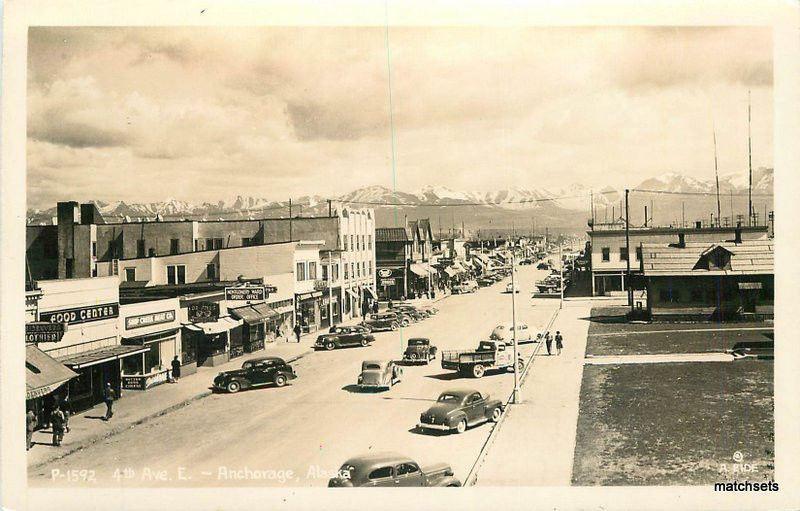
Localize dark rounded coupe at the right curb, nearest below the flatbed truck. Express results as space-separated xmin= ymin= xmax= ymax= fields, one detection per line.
xmin=417 ymin=389 xmax=503 ymax=433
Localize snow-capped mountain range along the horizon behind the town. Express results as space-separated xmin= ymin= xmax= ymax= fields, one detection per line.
xmin=28 ymin=168 xmax=773 ymax=229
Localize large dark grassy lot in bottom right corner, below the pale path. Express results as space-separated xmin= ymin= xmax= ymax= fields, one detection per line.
xmin=572 ymin=360 xmax=774 ymax=485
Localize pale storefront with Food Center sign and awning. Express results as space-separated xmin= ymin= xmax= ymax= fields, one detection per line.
xmin=35 ymin=277 xmax=149 ymax=411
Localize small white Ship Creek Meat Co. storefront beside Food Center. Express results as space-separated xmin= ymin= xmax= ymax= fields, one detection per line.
xmin=120 ymin=298 xmax=183 ymax=390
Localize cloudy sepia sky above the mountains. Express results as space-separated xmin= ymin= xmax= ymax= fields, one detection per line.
xmin=27 ymin=27 xmax=773 ymax=208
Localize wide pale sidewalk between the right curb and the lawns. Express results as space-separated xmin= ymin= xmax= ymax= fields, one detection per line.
xmin=475 ymin=302 xmax=592 ymax=486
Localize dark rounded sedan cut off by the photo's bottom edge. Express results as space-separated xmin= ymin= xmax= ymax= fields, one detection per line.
xmin=328 ymin=452 xmax=461 ymax=488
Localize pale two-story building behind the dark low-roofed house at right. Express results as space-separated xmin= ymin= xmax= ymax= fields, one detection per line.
xmin=587 ymin=223 xmax=767 ymax=296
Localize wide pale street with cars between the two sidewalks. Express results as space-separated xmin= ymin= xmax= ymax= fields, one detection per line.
xmin=29 ymin=266 xmax=558 ymax=486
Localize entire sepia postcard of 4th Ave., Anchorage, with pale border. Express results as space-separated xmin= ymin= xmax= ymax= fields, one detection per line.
xmin=2 ymin=2 xmax=798 ymax=509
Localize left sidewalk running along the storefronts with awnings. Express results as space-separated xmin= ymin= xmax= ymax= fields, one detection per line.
xmin=28 ymin=328 xmax=324 ymax=469
